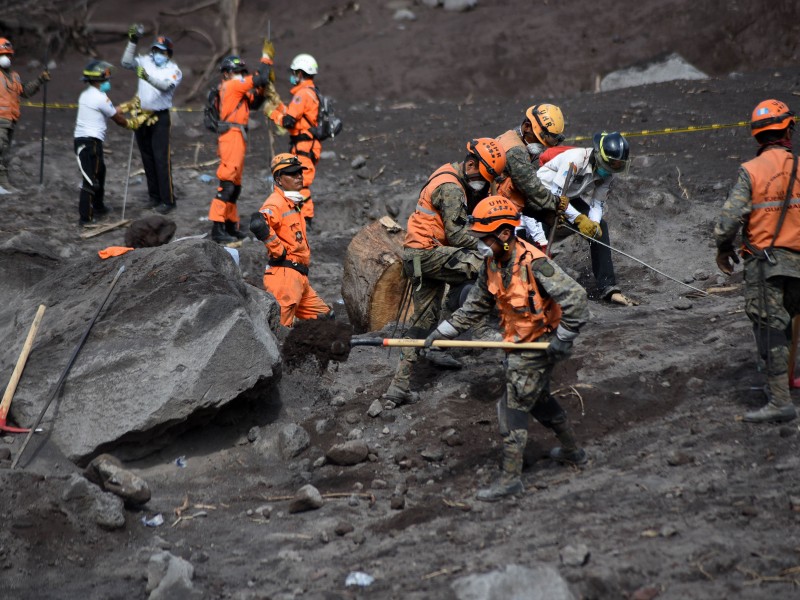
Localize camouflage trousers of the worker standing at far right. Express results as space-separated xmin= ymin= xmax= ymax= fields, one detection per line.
xmin=744 ymin=259 xmax=800 ymax=376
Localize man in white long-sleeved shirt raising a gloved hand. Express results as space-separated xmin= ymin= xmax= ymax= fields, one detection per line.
xmin=121 ymin=24 xmax=183 ymax=215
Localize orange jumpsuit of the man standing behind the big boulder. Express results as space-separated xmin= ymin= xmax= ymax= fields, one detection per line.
xmin=259 ymin=187 xmax=331 ymax=327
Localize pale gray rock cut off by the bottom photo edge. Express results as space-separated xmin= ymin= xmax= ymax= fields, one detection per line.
xmin=451 ymin=564 xmax=575 ymax=600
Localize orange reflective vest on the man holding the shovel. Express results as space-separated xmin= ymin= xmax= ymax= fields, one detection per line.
xmin=486 ymin=238 xmax=561 ymax=342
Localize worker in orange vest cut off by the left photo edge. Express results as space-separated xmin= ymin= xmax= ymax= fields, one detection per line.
xmin=0 ymin=38 xmax=50 ymax=194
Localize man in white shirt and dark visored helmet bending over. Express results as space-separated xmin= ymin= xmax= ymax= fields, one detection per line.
xmin=526 ymin=131 xmax=636 ymax=306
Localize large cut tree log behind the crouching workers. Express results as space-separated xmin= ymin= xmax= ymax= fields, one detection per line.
xmin=342 ymin=217 xmax=413 ymax=332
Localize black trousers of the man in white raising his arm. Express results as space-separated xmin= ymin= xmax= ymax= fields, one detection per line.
xmin=136 ymin=110 xmax=175 ymax=205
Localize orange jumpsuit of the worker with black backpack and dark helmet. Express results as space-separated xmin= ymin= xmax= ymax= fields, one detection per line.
xmin=208 ymin=75 xmax=260 ymax=224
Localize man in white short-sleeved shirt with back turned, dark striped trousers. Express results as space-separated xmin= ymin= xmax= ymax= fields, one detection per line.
xmin=73 ymin=60 xmax=136 ymax=227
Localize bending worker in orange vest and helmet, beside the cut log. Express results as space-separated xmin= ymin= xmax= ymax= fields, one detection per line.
xmin=383 ymin=138 xmax=506 ymax=405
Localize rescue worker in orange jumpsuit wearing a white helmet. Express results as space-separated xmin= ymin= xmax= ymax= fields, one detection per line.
xmin=268 ymin=54 xmax=322 ymax=225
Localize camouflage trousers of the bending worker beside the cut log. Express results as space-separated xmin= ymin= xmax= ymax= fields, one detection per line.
xmin=392 ymin=246 xmax=483 ymax=390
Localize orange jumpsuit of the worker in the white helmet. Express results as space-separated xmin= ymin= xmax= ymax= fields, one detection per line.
xmin=269 ymin=79 xmax=322 ymax=219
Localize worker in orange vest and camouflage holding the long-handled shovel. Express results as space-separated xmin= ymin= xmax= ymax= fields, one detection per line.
xmin=425 ymin=196 xmax=589 ymax=502
